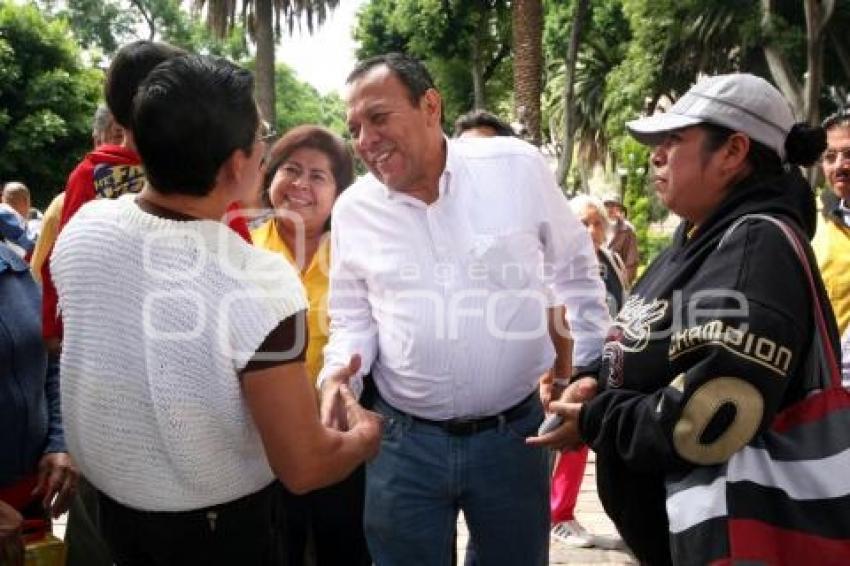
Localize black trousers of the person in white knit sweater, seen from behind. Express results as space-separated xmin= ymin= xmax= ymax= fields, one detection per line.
xmin=98 ymin=482 xmax=282 ymax=566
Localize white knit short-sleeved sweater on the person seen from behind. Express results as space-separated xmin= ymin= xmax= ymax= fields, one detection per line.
xmin=51 ymin=195 xmax=307 ymax=511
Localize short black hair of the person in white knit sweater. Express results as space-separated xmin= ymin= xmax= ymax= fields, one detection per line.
xmin=133 ymin=55 xmax=260 ymax=196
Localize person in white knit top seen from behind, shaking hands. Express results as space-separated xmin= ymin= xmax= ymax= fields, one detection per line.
xmin=52 ymin=56 xmax=380 ymax=565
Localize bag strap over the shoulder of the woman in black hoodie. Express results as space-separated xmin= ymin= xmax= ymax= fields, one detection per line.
xmin=717 ymin=214 xmax=841 ymax=388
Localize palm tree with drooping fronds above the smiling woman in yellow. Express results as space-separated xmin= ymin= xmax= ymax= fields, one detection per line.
xmin=192 ymin=0 xmax=339 ymax=124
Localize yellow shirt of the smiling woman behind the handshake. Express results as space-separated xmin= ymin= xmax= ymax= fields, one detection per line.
xmin=251 ymin=219 xmax=331 ymax=384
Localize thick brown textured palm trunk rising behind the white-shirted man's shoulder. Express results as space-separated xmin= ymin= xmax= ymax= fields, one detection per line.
xmin=511 ymin=0 xmax=543 ymax=145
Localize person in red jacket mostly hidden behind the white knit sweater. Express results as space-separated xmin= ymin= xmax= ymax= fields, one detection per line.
xmin=41 ymin=40 xmax=251 ymax=352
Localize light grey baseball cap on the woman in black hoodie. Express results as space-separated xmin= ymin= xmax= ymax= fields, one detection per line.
xmin=626 ymin=73 xmax=794 ymax=161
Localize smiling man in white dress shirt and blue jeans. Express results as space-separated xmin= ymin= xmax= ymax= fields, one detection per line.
xmin=319 ymin=54 xmax=609 ymax=566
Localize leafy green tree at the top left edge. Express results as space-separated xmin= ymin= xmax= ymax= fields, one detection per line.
xmin=0 ymin=3 xmax=102 ymax=209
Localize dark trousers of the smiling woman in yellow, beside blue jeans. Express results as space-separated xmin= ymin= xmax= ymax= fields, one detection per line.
xmin=283 ymin=466 xmax=372 ymax=566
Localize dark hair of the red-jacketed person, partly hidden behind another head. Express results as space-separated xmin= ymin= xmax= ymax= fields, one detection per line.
xmin=103 ymin=40 xmax=186 ymax=130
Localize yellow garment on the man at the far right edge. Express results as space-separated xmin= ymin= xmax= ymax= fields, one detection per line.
xmin=812 ymin=214 xmax=850 ymax=335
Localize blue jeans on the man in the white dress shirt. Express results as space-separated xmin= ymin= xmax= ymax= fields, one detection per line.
xmin=364 ymin=395 xmax=549 ymax=566
